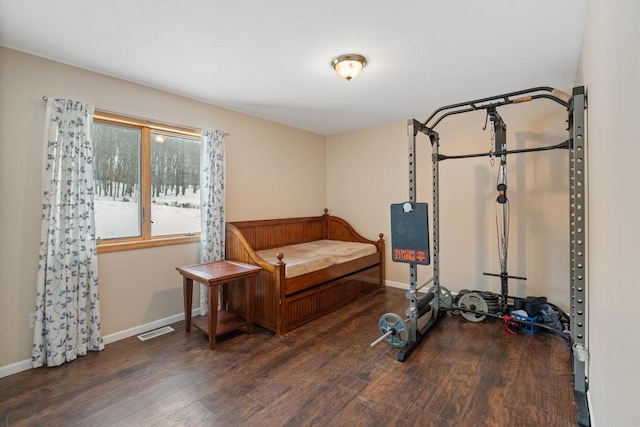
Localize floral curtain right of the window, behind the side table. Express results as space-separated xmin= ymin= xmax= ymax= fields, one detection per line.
xmin=200 ymin=130 xmax=225 ymax=315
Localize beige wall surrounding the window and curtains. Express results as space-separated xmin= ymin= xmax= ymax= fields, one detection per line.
xmin=0 ymin=48 xmax=326 ymax=368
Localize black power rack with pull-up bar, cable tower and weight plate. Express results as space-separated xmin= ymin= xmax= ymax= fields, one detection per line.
xmin=371 ymin=86 xmax=589 ymax=425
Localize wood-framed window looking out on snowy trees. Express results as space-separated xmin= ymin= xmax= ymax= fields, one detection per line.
xmin=91 ymin=111 xmax=202 ymax=253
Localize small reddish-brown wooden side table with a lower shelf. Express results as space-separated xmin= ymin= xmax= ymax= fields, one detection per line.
xmin=176 ymin=261 xmax=262 ymax=350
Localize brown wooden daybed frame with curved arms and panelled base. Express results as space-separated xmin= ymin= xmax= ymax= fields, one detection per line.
xmin=225 ymin=209 xmax=384 ymax=336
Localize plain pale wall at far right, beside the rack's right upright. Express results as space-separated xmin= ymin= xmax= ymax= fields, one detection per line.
xmin=578 ymin=0 xmax=640 ymax=427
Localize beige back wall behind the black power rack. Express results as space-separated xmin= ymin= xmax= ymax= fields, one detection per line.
xmin=327 ymin=100 xmax=569 ymax=312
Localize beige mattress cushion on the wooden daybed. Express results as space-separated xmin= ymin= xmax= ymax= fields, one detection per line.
xmin=257 ymin=240 xmax=376 ymax=277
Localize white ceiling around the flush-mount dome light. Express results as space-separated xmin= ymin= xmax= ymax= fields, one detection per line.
xmin=0 ymin=0 xmax=586 ymax=135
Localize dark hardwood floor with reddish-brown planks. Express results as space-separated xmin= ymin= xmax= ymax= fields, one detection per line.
xmin=0 ymin=288 xmax=576 ymax=427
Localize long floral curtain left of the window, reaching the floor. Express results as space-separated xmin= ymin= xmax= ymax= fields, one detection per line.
xmin=31 ymin=99 xmax=104 ymax=368
